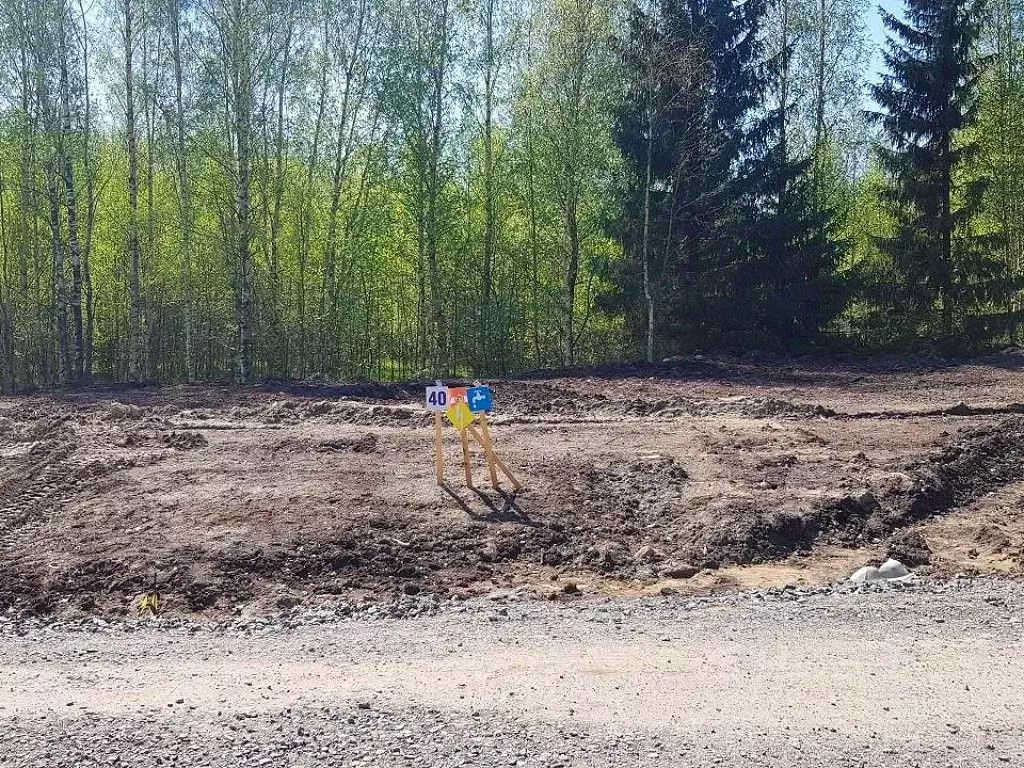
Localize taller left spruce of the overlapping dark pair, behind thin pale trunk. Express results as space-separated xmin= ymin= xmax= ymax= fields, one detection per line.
xmin=615 ymin=0 xmax=764 ymax=354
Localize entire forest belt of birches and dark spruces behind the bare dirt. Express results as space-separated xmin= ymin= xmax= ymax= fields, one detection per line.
xmin=0 ymin=0 xmax=1024 ymax=391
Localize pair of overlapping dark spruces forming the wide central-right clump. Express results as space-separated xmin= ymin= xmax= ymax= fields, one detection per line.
xmin=616 ymin=0 xmax=844 ymax=357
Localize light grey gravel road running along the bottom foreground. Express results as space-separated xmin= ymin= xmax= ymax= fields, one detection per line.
xmin=0 ymin=579 xmax=1024 ymax=768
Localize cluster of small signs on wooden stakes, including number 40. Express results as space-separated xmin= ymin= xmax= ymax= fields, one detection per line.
xmin=424 ymin=381 xmax=522 ymax=490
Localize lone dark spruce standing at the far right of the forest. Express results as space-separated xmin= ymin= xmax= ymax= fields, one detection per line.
xmin=871 ymin=0 xmax=1012 ymax=342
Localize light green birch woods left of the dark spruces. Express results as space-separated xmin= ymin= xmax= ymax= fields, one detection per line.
xmin=0 ymin=0 xmax=624 ymax=388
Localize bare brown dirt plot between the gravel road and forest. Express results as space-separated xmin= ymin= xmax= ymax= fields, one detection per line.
xmin=0 ymin=354 xmax=1024 ymax=614
